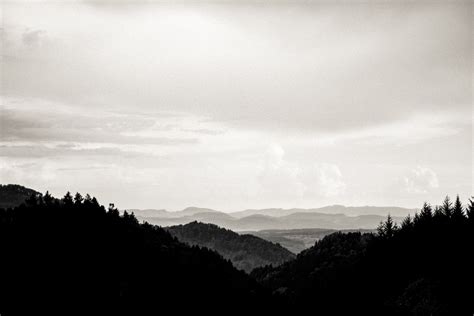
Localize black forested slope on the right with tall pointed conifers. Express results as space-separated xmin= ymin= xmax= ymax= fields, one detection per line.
xmin=252 ymin=198 xmax=474 ymax=315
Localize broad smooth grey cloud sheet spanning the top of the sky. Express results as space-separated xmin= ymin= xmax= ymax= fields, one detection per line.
xmin=2 ymin=3 xmax=472 ymax=133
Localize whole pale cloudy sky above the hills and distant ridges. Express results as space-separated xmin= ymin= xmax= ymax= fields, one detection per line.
xmin=0 ymin=1 xmax=473 ymax=212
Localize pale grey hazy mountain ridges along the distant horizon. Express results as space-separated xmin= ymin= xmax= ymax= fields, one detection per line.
xmin=129 ymin=205 xmax=415 ymax=231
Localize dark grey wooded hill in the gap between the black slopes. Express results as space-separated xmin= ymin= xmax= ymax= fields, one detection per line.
xmin=165 ymin=222 xmax=295 ymax=272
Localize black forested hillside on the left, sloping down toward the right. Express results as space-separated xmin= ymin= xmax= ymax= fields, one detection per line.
xmin=0 ymin=194 xmax=265 ymax=315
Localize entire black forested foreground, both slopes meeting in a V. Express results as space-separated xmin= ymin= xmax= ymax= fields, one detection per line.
xmin=0 ymin=193 xmax=474 ymax=315
